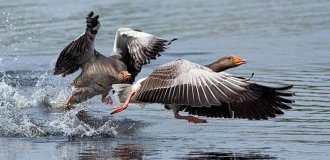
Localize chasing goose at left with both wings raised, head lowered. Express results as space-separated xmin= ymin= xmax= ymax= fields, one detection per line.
xmin=54 ymin=12 xmax=175 ymax=107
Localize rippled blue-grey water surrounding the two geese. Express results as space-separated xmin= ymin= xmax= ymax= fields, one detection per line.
xmin=0 ymin=0 xmax=330 ymax=159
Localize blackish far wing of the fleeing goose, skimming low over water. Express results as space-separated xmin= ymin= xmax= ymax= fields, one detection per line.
xmin=180 ymin=84 xmax=294 ymax=120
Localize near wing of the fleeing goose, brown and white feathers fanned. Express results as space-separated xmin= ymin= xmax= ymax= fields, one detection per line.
xmin=133 ymin=60 xmax=253 ymax=107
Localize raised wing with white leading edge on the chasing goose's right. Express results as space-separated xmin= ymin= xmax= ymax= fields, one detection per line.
xmin=113 ymin=28 xmax=176 ymax=82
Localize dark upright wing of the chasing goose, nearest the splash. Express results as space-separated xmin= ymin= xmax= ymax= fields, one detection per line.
xmin=54 ymin=12 xmax=100 ymax=77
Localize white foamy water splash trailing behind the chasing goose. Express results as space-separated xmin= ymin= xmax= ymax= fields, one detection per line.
xmin=0 ymin=72 xmax=139 ymax=137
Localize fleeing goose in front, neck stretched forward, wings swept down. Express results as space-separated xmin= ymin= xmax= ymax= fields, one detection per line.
xmin=111 ymin=56 xmax=293 ymax=123
